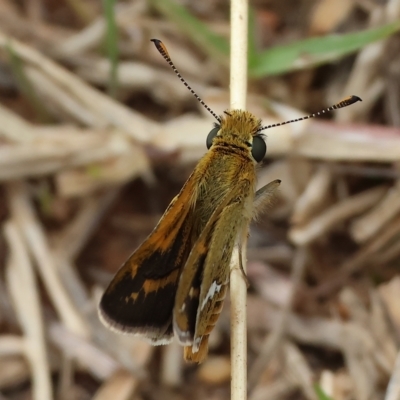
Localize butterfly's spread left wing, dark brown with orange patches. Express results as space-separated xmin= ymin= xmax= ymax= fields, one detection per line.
xmin=99 ymin=175 xmax=194 ymax=344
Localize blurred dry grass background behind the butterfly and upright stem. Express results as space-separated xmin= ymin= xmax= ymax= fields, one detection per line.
xmin=0 ymin=0 xmax=400 ymax=400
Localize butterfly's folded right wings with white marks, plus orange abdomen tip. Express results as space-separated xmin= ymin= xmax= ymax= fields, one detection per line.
xmin=173 ymin=181 xmax=252 ymax=362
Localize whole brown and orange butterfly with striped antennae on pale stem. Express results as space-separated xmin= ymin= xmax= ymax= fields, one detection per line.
xmin=99 ymin=39 xmax=361 ymax=363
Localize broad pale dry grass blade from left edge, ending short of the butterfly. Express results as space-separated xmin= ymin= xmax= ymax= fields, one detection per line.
xmin=0 ymin=126 xmax=148 ymax=181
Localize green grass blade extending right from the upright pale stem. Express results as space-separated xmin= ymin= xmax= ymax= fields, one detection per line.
xmin=249 ymin=21 xmax=400 ymax=78
